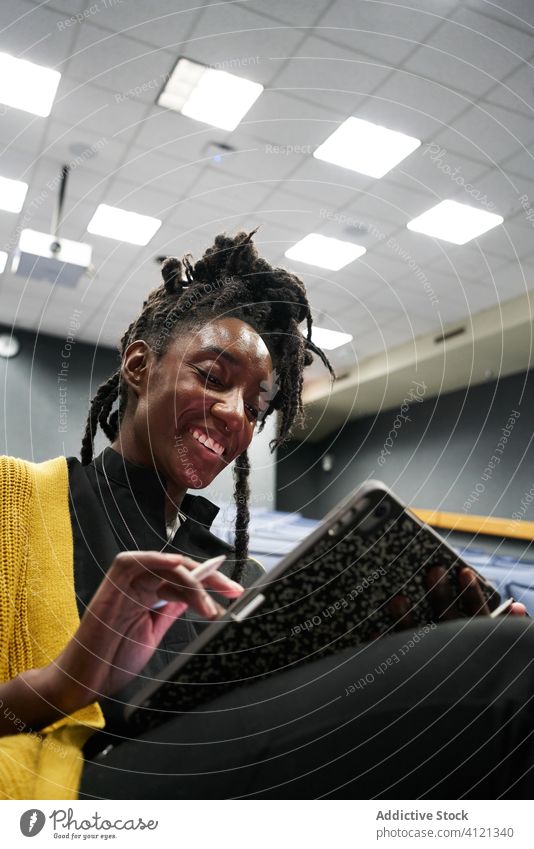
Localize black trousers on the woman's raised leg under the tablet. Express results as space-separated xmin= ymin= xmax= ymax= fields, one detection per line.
xmin=80 ymin=617 xmax=534 ymax=799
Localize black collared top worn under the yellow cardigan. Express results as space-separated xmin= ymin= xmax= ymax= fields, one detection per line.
xmin=67 ymin=447 xmax=261 ymax=749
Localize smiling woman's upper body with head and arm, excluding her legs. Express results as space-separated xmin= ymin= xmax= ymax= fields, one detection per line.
xmin=0 ymin=233 xmax=332 ymax=798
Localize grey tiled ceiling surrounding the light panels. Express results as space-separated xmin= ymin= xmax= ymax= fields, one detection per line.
xmin=0 ymin=0 xmax=534 ymax=420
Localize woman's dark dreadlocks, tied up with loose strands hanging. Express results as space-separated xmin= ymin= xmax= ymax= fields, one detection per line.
xmin=81 ymin=231 xmax=335 ymax=580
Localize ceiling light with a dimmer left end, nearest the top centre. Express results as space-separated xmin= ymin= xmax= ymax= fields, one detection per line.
xmin=157 ymin=59 xmax=263 ymax=130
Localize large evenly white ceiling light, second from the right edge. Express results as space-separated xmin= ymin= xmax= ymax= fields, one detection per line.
xmin=313 ymin=118 xmax=421 ymax=177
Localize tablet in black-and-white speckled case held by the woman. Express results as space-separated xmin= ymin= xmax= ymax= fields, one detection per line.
xmin=125 ymin=481 xmax=500 ymax=731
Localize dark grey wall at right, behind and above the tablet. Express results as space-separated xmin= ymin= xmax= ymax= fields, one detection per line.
xmin=277 ymin=372 xmax=534 ymax=521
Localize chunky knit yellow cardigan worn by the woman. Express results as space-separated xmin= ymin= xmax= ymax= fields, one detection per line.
xmin=0 ymin=457 xmax=104 ymax=799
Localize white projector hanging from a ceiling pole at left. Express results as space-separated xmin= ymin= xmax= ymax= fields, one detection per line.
xmin=11 ymin=165 xmax=92 ymax=288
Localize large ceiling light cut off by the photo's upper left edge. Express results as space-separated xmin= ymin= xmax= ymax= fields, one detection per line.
xmin=0 ymin=53 xmax=61 ymax=118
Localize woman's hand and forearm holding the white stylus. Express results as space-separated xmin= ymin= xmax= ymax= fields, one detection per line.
xmin=49 ymin=551 xmax=243 ymax=713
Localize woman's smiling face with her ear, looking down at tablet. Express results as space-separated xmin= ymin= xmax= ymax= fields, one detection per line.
xmin=124 ymin=318 xmax=273 ymax=489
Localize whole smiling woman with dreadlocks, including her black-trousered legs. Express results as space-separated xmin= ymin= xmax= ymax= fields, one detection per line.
xmin=0 ymin=233 xmax=534 ymax=799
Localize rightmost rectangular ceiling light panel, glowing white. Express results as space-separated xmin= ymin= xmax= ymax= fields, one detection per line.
xmin=406 ymin=200 xmax=504 ymax=245
